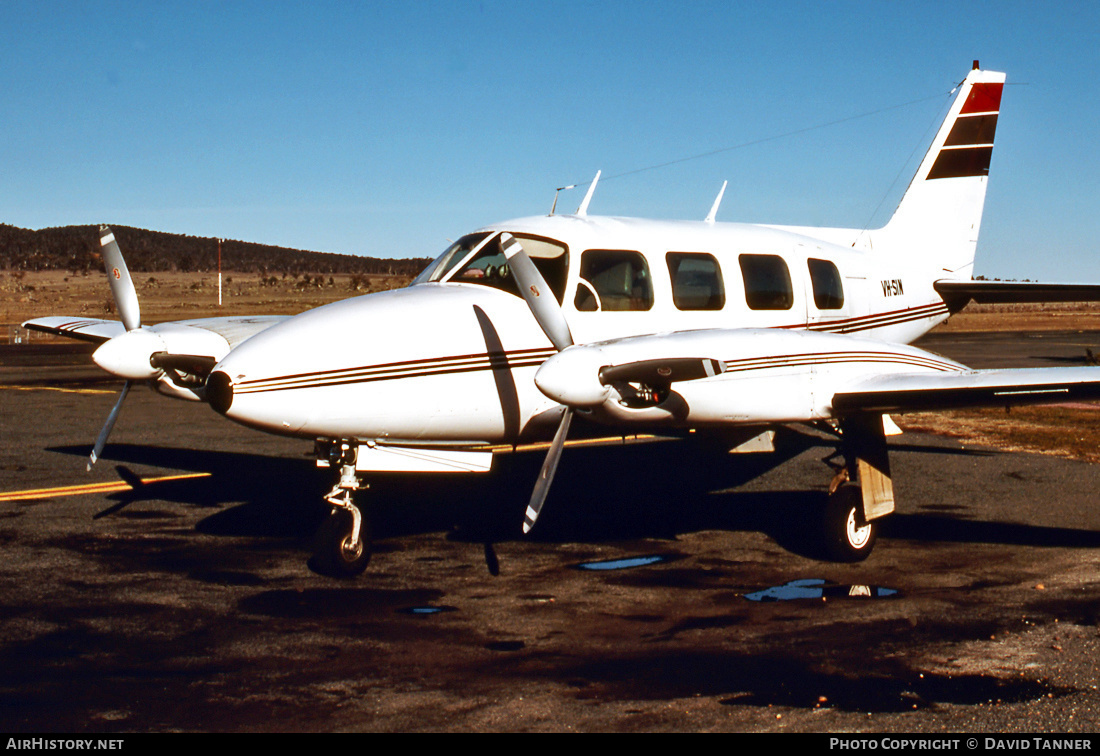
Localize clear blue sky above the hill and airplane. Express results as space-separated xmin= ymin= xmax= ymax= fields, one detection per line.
xmin=0 ymin=0 xmax=1100 ymax=282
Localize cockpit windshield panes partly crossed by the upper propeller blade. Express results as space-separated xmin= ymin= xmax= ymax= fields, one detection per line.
xmin=413 ymin=232 xmax=569 ymax=303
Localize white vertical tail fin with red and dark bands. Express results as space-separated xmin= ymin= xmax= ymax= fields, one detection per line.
xmin=873 ymin=62 xmax=1004 ymax=278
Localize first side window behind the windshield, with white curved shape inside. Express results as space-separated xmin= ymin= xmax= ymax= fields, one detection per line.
xmin=573 ymin=250 xmax=653 ymax=313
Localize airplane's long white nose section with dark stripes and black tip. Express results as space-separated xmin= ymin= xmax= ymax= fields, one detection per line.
xmin=199 ymin=284 xmax=552 ymax=439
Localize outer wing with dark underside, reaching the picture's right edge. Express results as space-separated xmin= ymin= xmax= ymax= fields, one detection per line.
xmin=833 ymin=368 xmax=1100 ymax=416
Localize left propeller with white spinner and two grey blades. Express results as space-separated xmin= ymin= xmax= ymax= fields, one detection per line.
xmin=88 ymin=226 xmax=164 ymax=470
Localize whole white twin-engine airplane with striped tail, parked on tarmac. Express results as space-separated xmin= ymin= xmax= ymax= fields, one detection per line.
xmin=25 ymin=63 xmax=1100 ymax=576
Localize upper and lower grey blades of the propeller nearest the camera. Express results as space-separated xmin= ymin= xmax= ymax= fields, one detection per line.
xmin=501 ymin=232 xmax=573 ymax=533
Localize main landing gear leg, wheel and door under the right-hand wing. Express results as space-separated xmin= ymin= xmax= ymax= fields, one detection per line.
xmin=820 ymin=415 xmax=894 ymax=562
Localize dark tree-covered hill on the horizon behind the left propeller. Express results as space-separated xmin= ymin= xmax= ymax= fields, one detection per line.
xmin=0 ymin=223 xmax=430 ymax=275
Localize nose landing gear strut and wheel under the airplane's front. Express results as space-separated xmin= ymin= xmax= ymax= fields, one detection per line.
xmin=312 ymin=441 xmax=371 ymax=578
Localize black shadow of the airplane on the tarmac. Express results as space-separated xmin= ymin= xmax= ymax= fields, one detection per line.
xmin=50 ymin=429 xmax=1100 ymax=557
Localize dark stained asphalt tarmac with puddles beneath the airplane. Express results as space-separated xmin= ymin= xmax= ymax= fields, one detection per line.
xmin=0 ymin=333 xmax=1100 ymax=733
